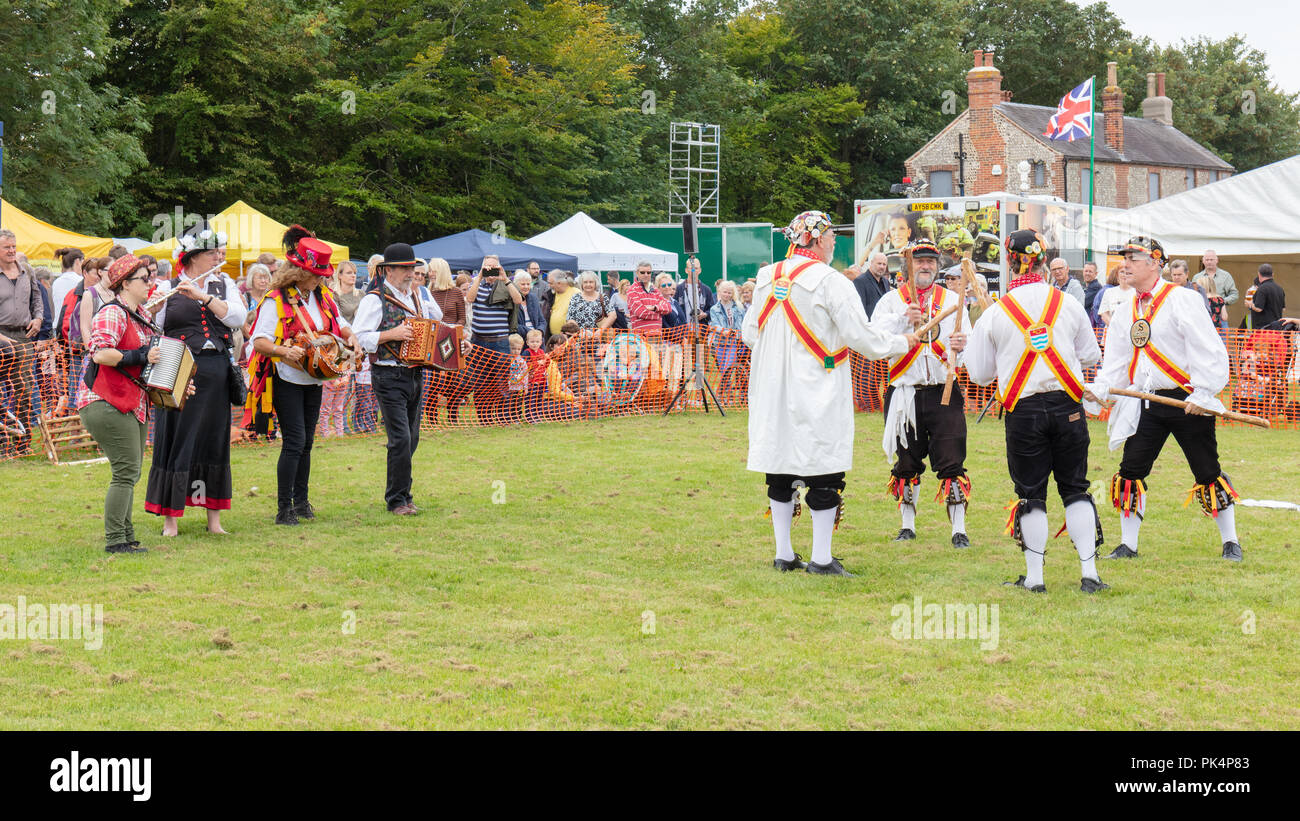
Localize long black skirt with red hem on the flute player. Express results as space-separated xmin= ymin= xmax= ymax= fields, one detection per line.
xmin=144 ymin=351 xmax=233 ymax=516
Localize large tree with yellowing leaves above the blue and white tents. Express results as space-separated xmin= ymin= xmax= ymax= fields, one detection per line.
xmin=307 ymin=0 xmax=640 ymax=246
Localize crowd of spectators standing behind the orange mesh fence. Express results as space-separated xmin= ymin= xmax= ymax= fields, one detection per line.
xmin=0 ymin=240 xmax=1300 ymax=455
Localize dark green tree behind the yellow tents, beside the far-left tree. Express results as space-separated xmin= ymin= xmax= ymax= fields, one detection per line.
xmin=111 ymin=0 xmax=330 ymax=234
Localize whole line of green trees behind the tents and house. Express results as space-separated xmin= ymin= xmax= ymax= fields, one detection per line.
xmin=0 ymin=0 xmax=1300 ymax=248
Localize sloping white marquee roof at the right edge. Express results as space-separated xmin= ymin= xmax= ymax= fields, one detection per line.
xmin=1104 ymin=155 xmax=1300 ymax=256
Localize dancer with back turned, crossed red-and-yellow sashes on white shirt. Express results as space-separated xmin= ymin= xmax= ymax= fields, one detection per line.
xmin=966 ymin=230 xmax=1110 ymax=592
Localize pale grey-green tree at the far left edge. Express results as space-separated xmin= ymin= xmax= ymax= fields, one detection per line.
xmin=0 ymin=0 xmax=146 ymax=234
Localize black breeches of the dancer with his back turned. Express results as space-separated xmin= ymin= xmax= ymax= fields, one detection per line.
xmin=1005 ymin=391 xmax=1089 ymax=511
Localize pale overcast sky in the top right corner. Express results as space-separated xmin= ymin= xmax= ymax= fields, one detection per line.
xmin=1075 ymin=0 xmax=1300 ymax=94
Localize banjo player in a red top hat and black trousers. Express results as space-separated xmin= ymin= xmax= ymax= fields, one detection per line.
xmin=244 ymin=225 xmax=358 ymax=525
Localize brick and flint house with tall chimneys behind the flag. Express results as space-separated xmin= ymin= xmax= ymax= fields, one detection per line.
xmin=906 ymin=51 xmax=1234 ymax=208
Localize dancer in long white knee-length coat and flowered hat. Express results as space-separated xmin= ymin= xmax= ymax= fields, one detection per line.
xmin=741 ymin=210 xmax=917 ymax=575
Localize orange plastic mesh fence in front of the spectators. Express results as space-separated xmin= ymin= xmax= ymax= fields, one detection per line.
xmin=0 ymin=327 xmax=1300 ymax=460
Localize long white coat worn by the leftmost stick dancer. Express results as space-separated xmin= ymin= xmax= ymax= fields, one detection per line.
xmin=741 ymin=256 xmax=907 ymax=475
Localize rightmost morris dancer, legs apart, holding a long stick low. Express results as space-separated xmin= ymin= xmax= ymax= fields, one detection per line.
xmin=1089 ymin=236 xmax=1242 ymax=561
